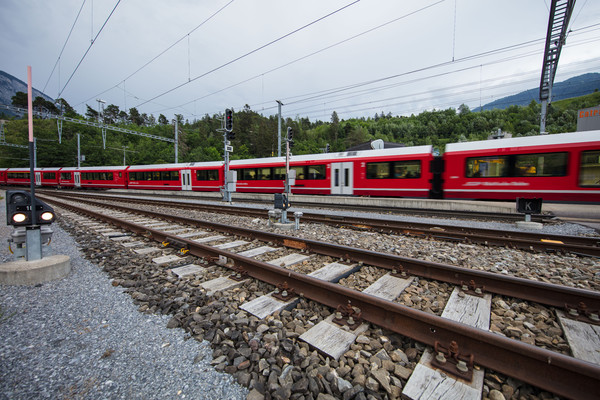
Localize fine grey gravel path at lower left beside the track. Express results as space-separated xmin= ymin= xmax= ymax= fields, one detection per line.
xmin=0 ymin=200 xmax=247 ymax=399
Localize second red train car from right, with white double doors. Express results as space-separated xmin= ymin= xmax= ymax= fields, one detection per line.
xmin=230 ymin=146 xmax=433 ymax=197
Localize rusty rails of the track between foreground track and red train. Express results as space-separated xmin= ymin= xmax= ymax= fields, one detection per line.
xmin=41 ymin=193 xmax=600 ymax=257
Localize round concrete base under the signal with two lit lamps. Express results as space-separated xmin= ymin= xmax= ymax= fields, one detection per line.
xmin=0 ymin=255 xmax=71 ymax=285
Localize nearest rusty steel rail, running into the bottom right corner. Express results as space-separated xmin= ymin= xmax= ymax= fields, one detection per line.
xmin=42 ymin=194 xmax=600 ymax=399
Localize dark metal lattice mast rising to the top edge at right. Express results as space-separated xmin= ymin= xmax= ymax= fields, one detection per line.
xmin=540 ymin=0 xmax=575 ymax=134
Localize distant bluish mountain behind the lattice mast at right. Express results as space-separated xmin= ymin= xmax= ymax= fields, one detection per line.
xmin=476 ymin=73 xmax=600 ymax=111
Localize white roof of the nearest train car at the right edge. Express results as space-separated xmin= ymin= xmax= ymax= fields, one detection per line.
xmin=446 ymin=131 xmax=600 ymax=153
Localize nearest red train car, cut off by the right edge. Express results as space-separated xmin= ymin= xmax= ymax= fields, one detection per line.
xmin=443 ymin=131 xmax=600 ymax=202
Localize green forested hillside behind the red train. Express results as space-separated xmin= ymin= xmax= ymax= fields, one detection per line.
xmin=0 ymin=92 xmax=600 ymax=168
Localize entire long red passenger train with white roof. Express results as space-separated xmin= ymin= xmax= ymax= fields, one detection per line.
xmin=0 ymin=131 xmax=600 ymax=202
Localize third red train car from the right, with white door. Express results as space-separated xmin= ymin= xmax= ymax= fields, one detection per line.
xmin=127 ymin=161 xmax=223 ymax=191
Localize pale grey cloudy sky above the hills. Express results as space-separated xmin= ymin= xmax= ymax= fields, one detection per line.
xmin=0 ymin=0 xmax=600 ymax=121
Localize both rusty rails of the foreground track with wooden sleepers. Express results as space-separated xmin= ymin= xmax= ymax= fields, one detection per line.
xmin=38 ymin=192 xmax=600 ymax=398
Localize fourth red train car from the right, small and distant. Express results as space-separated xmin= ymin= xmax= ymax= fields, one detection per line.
xmin=65 ymin=166 xmax=128 ymax=189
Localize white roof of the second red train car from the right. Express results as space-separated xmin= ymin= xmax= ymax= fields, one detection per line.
xmin=230 ymin=145 xmax=432 ymax=166
